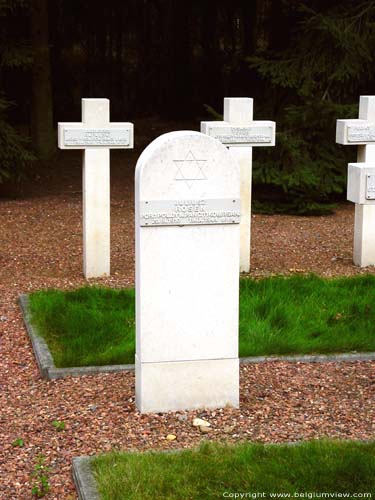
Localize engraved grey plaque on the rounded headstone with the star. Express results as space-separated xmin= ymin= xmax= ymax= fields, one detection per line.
xmin=139 ymin=198 xmax=241 ymax=227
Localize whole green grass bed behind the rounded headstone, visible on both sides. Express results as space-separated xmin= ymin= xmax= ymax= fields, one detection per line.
xmin=30 ymin=275 xmax=375 ymax=367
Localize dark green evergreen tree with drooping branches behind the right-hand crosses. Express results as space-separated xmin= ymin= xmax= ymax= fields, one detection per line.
xmin=249 ymin=2 xmax=375 ymax=213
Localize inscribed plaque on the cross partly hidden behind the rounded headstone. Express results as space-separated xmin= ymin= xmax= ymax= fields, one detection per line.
xmin=208 ymin=126 xmax=272 ymax=144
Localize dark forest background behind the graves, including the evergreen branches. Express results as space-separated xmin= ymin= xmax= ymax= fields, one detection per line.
xmin=0 ymin=0 xmax=375 ymax=214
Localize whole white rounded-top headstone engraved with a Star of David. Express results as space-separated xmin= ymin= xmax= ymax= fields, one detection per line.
xmin=135 ymin=131 xmax=240 ymax=413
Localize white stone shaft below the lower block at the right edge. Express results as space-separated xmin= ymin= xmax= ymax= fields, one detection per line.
xmin=353 ymin=203 xmax=375 ymax=267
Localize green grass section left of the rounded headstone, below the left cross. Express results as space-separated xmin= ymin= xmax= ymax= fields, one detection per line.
xmin=30 ymin=287 xmax=135 ymax=368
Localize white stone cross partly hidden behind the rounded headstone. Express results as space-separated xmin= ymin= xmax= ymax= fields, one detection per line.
xmin=201 ymin=97 xmax=276 ymax=272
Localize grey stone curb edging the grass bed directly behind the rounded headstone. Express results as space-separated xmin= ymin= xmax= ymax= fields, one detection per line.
xmin=19 ymin=294 xmax=375 ymax=380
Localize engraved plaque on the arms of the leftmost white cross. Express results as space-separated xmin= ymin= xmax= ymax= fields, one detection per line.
xmin=64 ymin=128 xmax=130 ymax=147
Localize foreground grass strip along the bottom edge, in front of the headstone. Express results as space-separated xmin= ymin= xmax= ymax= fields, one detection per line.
xmin=93 ymin=441 xmax=375 ymax=500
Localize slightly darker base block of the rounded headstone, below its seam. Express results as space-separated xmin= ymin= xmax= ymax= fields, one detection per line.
xmin=135 ymin=356 xmax=239 ymax=413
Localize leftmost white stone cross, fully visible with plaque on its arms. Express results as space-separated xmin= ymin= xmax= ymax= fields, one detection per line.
xmin=58 ymin=99 xmax=133 ymax=278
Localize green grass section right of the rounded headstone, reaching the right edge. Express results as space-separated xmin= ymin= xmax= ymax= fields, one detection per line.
xmin=239 ymin=275 xmax=375 ymax=356
